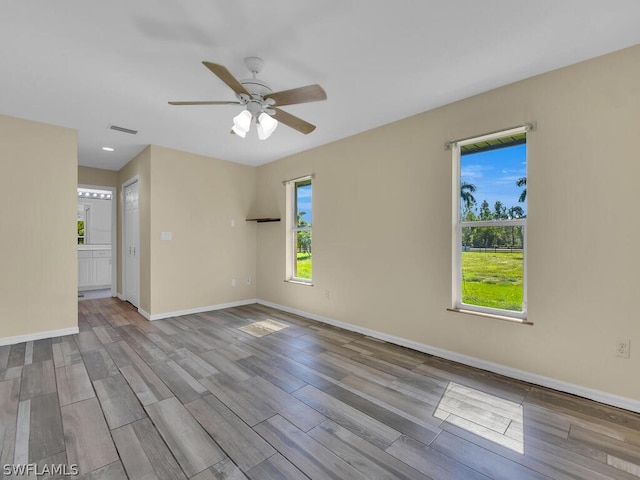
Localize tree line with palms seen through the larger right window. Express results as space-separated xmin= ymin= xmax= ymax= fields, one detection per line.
xmin=460 ymin=177 xmax=527 ymax=249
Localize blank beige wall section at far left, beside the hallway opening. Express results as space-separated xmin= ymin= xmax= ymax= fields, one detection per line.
xmin=0 ymin=115 xmax=78 ymax=342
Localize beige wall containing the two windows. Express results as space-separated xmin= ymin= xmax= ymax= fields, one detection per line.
xmin=257 ymin=47 xmax=640 ymax=400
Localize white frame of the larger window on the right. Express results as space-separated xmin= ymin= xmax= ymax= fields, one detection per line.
xmin=448 ymin=125 xmax=532 ymax=321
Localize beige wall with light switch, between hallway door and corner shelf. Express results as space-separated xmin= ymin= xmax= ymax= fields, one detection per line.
xmin=149 ymin=146 xmax=257 ymax=315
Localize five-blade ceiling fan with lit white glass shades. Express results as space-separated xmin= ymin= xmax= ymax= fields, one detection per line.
xmin=169 ymin=57 xmax=327 ymax=140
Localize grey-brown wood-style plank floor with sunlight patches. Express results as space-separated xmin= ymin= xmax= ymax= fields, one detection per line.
xmin=0 ymin=298 xmax=640 ymax=480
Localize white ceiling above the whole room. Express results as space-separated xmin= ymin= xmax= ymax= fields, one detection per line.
xmin=0 ymin=0 xmax=640 ymax=170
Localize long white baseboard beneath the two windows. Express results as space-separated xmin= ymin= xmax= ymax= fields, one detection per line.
xmin=257 ymin=299 xmax=640 ymax=413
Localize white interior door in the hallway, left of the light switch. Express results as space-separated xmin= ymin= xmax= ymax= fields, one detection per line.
xmin=122 ymin=180 xmax=140 ymax=307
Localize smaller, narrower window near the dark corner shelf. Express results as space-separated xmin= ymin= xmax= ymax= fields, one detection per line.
xmin=287 ymin=177 xmax=312 ymax=283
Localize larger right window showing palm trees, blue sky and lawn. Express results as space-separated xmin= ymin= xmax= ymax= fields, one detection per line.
xmin=453 ymin=127 xmax=527 ymax=319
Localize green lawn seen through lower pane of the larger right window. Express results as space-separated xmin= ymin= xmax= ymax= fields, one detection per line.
xmin=462 ymin=252 xmax=524 ymax=311
